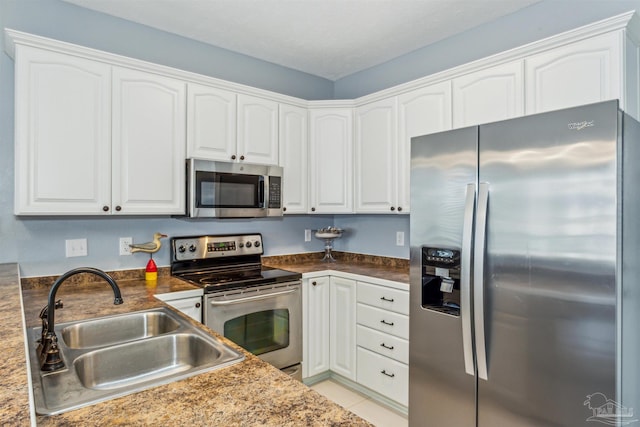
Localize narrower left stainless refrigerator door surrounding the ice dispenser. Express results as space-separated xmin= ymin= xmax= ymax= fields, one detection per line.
xmin=409 ymin=127 xmax=477 ymax=427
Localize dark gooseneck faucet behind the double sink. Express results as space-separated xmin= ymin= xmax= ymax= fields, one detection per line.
xmin=37 ymin=267 xmax=123 ymax=371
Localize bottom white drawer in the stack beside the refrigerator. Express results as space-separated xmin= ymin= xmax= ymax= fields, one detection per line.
xmin=357 ymin=347 xmax=409 ymax=406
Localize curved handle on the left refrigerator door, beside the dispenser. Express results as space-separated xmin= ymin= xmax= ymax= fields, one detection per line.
xmin=460 ymin=183 xmax=476 ymax=375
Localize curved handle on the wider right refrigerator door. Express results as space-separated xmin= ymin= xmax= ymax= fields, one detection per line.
xmin=473 ymin=182 xmax=489 ymax=380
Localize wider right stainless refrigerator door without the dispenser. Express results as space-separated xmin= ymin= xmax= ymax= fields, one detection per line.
xmin=478 ymin=102 xmax=619 ymax=427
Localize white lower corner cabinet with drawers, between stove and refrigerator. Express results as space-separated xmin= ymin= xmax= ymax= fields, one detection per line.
xmin=302 ymin=271 xmax=409 ymax=406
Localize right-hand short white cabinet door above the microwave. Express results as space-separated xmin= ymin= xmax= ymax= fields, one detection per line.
xmin=236 ymin=95 xmax=278 ymax=165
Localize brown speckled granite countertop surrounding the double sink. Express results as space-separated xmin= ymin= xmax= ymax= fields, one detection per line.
xmin=0 ymin=264 xmax=370 ymax=426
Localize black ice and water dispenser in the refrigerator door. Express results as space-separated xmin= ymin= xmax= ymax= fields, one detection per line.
xmin=422 ymin=247 xmax=460 ymax=316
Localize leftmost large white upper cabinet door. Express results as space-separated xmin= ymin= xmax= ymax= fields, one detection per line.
xmin=14 ymin=45 xmax=111 ymax=215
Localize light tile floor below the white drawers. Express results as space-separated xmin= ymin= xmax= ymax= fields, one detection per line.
xmin=311 ymin=380 xmax=409 ymax=427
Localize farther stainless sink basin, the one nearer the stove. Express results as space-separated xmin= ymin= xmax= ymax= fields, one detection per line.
xmin=60 ymin=311 xmax=180 ymax=348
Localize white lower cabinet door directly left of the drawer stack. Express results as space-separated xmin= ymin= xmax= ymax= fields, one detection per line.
xmin=329 ymin=277 xmax=356 ymax=381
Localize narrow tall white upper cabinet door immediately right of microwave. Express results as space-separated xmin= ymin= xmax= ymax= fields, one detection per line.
xmin=279 ymin=104 xmax=309 ymax=214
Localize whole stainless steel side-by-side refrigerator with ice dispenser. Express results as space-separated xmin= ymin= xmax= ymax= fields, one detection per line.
xmin=409 ymin=101 xmax=640 ymax=427
